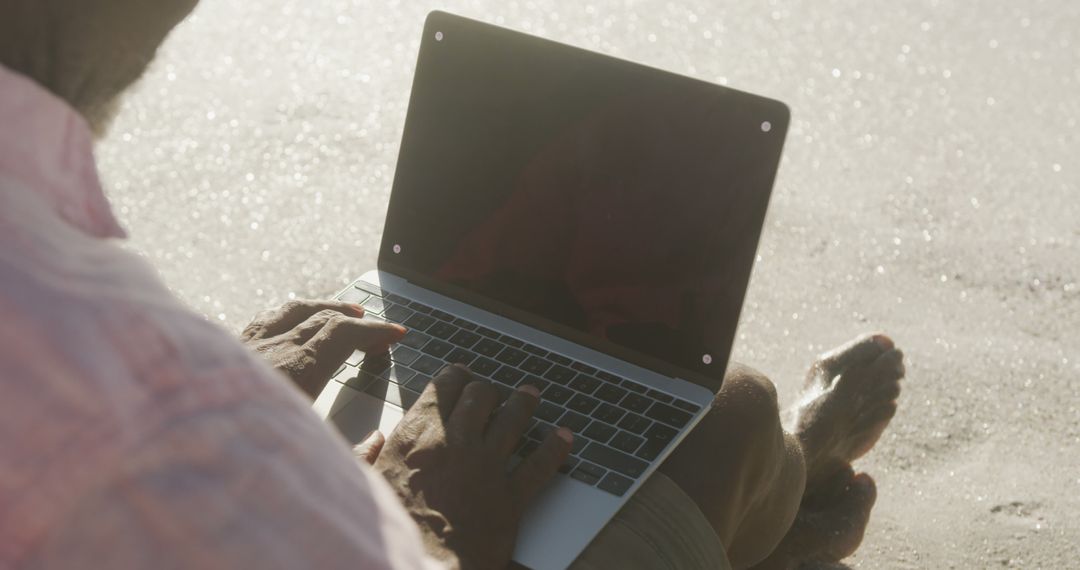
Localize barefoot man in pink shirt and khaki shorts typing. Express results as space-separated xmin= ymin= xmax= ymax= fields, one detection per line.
xmin=0 ymin=0 xmax=904 ymax=569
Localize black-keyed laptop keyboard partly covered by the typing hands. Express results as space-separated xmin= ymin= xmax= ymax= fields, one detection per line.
xmin=334 ymin=282 xmax=701 ymax=496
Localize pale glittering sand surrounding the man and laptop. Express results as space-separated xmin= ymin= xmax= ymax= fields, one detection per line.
xmin=98 ymin=0 xmax=1080 ymax=569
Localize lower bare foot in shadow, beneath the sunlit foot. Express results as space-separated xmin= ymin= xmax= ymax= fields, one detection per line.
xmin=755 ymin=467 xmax=877 ymax=570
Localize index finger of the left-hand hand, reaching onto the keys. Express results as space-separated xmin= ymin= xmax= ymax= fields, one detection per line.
xmin=305 ymin=315 xmax=405 ymax=378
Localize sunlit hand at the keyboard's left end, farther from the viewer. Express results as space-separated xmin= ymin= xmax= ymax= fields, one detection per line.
xmin=240 ymin=300 xmax=405 ymax=398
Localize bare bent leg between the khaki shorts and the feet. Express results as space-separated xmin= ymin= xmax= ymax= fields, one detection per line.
xmin=660 ymin=364 xmax=806 ymax=568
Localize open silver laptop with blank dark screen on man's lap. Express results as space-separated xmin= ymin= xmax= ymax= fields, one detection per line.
xmin=315 ymin=12 xmax=788 ymax=570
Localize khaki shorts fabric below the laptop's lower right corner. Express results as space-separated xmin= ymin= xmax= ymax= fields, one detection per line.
xmin=570 ymin=473 xmax=731 ymax=570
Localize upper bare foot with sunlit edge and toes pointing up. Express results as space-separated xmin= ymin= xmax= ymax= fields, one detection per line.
xmin=793 ymin=335 xmax=904 ymax=498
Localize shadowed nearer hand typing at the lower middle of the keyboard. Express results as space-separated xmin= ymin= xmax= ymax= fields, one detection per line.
xmin=375 ymin=366 xmax=573 ymax=569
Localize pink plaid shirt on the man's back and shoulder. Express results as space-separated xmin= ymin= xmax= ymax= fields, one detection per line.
xmin=0 ymin=67 xmax=437 ymax=569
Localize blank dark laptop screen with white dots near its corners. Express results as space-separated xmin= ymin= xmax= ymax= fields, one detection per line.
xmin=379 ymin=13 xmax=787 ymax=389
